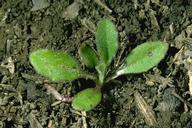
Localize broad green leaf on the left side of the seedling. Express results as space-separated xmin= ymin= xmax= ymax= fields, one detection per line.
xmin=29 ymin=49 xmax=83 ymax=81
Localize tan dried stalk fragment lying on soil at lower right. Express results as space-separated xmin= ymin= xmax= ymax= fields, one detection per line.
xmin=134 ymin=91 xmax=157 ymax=126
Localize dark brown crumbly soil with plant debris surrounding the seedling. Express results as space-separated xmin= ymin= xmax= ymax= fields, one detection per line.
xmin=0 ymin=0 xmax=192 ymax=128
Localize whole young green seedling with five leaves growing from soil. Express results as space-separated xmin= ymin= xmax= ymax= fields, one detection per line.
xmin=29 ymin=19 xmax=168 ymax=111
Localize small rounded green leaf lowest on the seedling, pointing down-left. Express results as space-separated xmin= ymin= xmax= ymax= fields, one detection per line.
xmin=72 ymin=88 xmax=102 ymax=111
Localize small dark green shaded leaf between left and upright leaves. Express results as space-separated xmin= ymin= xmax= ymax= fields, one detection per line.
xmin=79 ymin=44 xmax=98 ymax=68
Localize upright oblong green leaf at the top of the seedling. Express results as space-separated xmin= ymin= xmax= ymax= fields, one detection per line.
xmin=96 ymin=19 xmax=118 ymax=65
